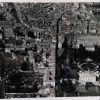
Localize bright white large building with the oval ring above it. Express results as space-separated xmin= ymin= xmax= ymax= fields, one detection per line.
xmin=79 ymin=63 xmax=100 ymax=86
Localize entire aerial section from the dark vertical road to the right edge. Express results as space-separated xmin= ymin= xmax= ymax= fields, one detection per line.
xmin=55 ymin=2 xmax=100 ymax=97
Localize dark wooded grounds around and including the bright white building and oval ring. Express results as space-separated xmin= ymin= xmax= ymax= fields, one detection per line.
xmin=57 ymin=35 xmax=100 ymax=96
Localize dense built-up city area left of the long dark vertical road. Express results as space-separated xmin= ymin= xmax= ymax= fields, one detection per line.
xmin=0 ymin=2 xmax=55 ymax=98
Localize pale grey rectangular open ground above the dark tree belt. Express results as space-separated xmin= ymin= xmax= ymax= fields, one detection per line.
xmin=74 ymin=35 xmax=100 ymax=51
